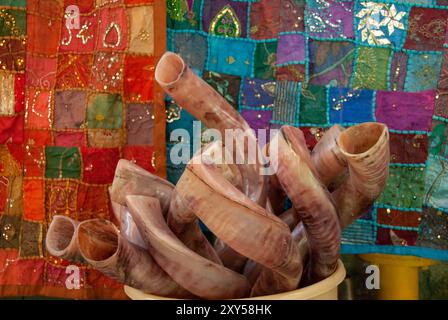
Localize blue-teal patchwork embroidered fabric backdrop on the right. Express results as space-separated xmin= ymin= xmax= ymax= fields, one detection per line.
xmin=167 ymin=0 xmax=448 ymax=260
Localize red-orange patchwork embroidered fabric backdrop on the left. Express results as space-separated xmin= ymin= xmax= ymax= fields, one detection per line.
xmin=0 ymin=0 xmax=166 ymax=298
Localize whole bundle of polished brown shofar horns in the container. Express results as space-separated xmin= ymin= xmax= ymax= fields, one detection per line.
xmin=46 ymin=52 xmax=389 ymax=299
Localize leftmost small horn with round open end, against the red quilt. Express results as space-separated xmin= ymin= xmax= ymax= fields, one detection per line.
xmin=45 ymin=216 xmax=81 ymax=261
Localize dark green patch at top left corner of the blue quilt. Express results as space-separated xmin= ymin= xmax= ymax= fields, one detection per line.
xmin=166 ymin=0 xmax=201 ymax=30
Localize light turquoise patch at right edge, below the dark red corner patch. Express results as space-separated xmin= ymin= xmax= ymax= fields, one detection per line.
xmin=405 ymin=53 xmax=443 ymax=92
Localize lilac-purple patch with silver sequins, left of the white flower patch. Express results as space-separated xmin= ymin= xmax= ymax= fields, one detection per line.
xmin=308 ymin=0 xmax=355 ymax=38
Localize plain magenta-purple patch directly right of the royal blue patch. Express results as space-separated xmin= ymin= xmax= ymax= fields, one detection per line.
xmin=375 ymin=90 xmax=435 ymax=131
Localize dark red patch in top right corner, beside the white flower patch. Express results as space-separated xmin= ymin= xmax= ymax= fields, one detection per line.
xmin=404 ymin=7 xmax=448 ymax=51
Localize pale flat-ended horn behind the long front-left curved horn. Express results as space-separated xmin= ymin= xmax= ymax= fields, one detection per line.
xmin=110 ymin=159 xmax=174 ymax=214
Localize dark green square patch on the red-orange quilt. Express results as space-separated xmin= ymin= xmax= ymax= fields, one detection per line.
xmin=45 ymin=146 xmax=81 ymax=179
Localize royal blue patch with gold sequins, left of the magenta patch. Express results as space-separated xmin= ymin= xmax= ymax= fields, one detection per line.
xmin=328 ymin=87 xmax=373 ymax=123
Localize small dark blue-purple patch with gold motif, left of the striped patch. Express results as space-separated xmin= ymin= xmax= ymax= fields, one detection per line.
xmin=241 ymin=78 xmax=275 ymax=107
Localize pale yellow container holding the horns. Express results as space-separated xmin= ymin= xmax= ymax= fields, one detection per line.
xmin=124 ymin=260 xmax=345 ymax=300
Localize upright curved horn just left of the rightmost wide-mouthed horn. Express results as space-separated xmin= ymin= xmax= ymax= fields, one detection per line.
xmin=275 ymin=126 xmax=341 ymax=281
